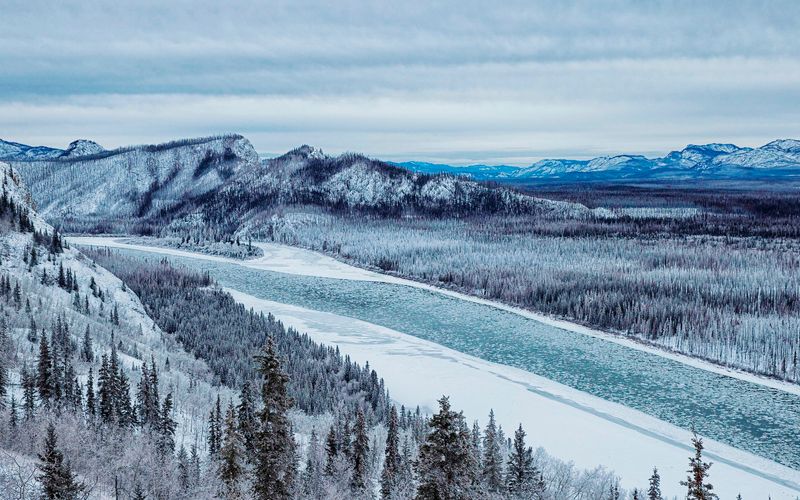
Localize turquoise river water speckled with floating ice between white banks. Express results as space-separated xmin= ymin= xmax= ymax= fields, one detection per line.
xmin=119 ymin=250 xmax=800 ymax=468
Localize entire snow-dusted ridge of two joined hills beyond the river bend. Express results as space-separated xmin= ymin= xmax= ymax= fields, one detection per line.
xmin=7 ymin=135 xmax=589 ymax=234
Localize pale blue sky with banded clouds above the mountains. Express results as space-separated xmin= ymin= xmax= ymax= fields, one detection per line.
xmin=0 ymin=0 xmax=800 ymax=165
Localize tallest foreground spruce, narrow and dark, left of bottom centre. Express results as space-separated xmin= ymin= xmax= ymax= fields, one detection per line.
xmin=253 ymin=337 xmax=295 ymax=500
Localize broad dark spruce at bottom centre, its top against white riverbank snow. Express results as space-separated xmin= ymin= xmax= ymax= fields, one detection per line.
xmin=417 ymin=397 xmax=475 ymax=500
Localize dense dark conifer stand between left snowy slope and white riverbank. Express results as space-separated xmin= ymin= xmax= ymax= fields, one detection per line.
xmin=87 ymin=250 xmax=388 ymax=422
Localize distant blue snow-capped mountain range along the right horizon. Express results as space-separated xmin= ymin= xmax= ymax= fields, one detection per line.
xmin=396 ymin=139 xmax=800 ymax=182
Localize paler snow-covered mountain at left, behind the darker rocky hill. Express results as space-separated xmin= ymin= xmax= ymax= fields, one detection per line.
xmin=15 ymin=135 xmax=258 ymax=229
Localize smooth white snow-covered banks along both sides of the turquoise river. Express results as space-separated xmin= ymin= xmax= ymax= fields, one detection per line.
xmin=70 ymin=237 xmax=800 ymax=499
